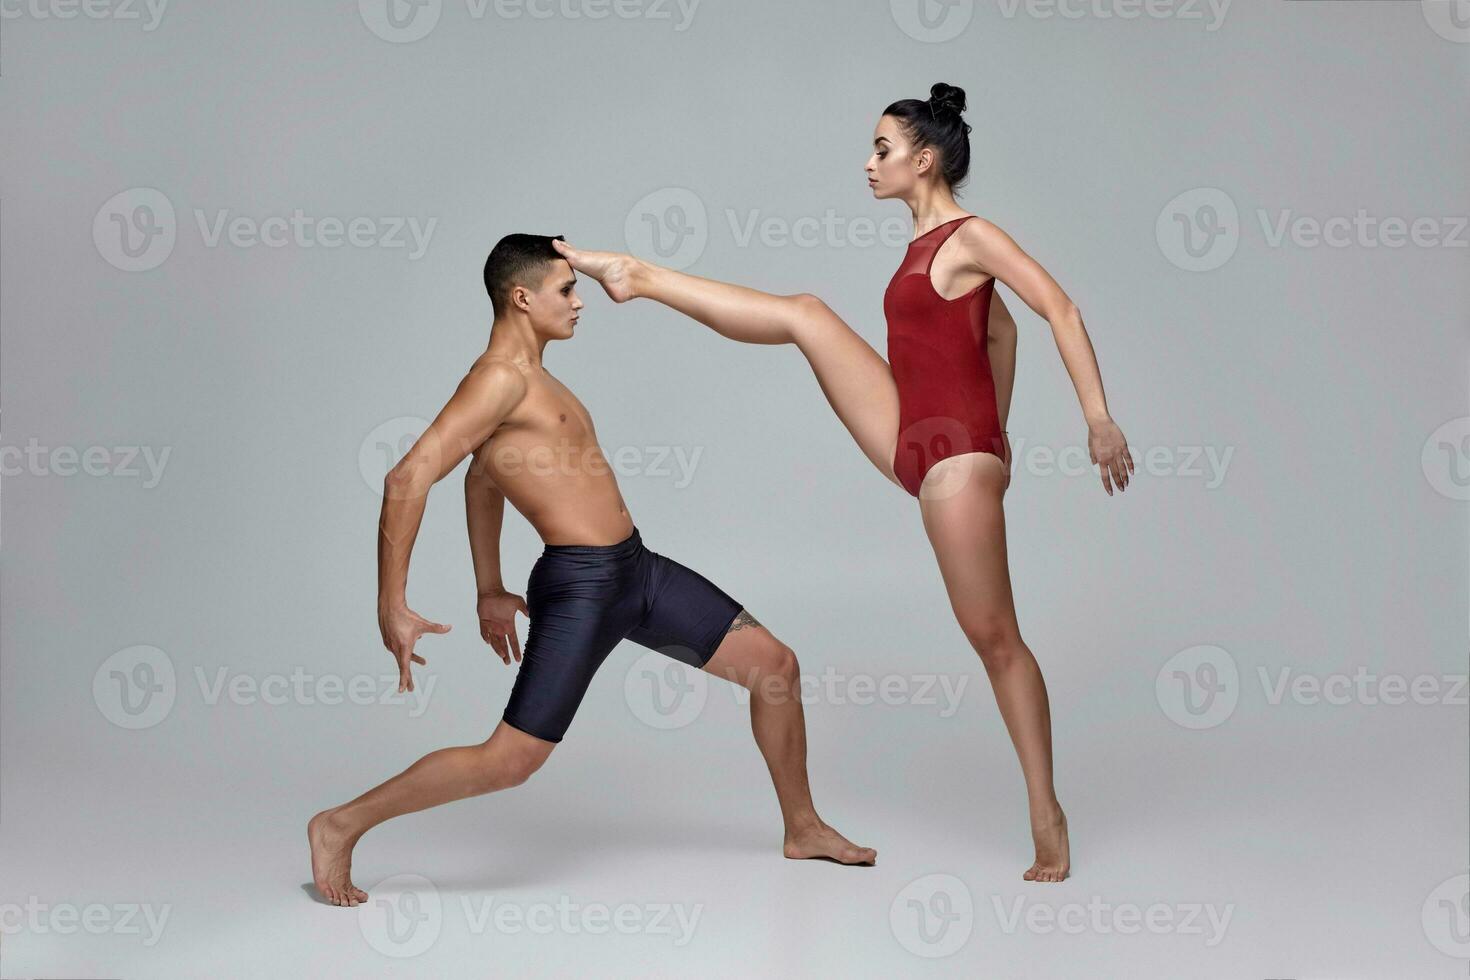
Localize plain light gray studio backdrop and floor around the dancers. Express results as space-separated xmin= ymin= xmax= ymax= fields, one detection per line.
xmin=0 ymin=0 xmax=1470 ymax=977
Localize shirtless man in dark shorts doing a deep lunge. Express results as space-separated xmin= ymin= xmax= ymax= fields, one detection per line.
xmin=307 ymin=235 xmax=878 ymax=907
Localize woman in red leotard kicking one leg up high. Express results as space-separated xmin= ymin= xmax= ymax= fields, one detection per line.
xmin=554 ymin=84 xmax=1133 ymax=882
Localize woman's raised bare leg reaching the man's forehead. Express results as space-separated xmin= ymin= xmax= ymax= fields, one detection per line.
xmin=554 ymin=241 xmax=898 ymax=483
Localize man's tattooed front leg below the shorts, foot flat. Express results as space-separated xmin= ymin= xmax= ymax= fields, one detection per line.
xmin=704 ymin=610 xmax=878 ymax=864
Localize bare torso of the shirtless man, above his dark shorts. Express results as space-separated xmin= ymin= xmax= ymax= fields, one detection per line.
xmin=470 ymin=351 xmax=634 ymax=545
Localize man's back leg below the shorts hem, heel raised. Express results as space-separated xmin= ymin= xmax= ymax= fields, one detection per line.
xmin=306 ymin=721 xmax=556 ymax=907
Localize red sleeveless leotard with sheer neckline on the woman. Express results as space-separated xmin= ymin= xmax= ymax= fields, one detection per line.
xmin=883 ymin=215 xmax=1005 ymax=497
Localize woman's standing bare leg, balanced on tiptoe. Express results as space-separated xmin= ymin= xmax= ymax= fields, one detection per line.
xmin=919 ymin=453 xmax=1070 ymax=882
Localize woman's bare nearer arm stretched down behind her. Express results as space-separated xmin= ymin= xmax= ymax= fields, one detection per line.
xmin=954 ymin=217 xmax=1133 ymax=495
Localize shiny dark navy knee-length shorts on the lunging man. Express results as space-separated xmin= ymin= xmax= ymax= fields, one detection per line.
xmin=503 ymin=527 xmax=741 ymax=742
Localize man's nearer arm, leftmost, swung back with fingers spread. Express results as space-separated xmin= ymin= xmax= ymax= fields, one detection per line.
xmin=378 ymin=361 xmax=526 ymax=692
